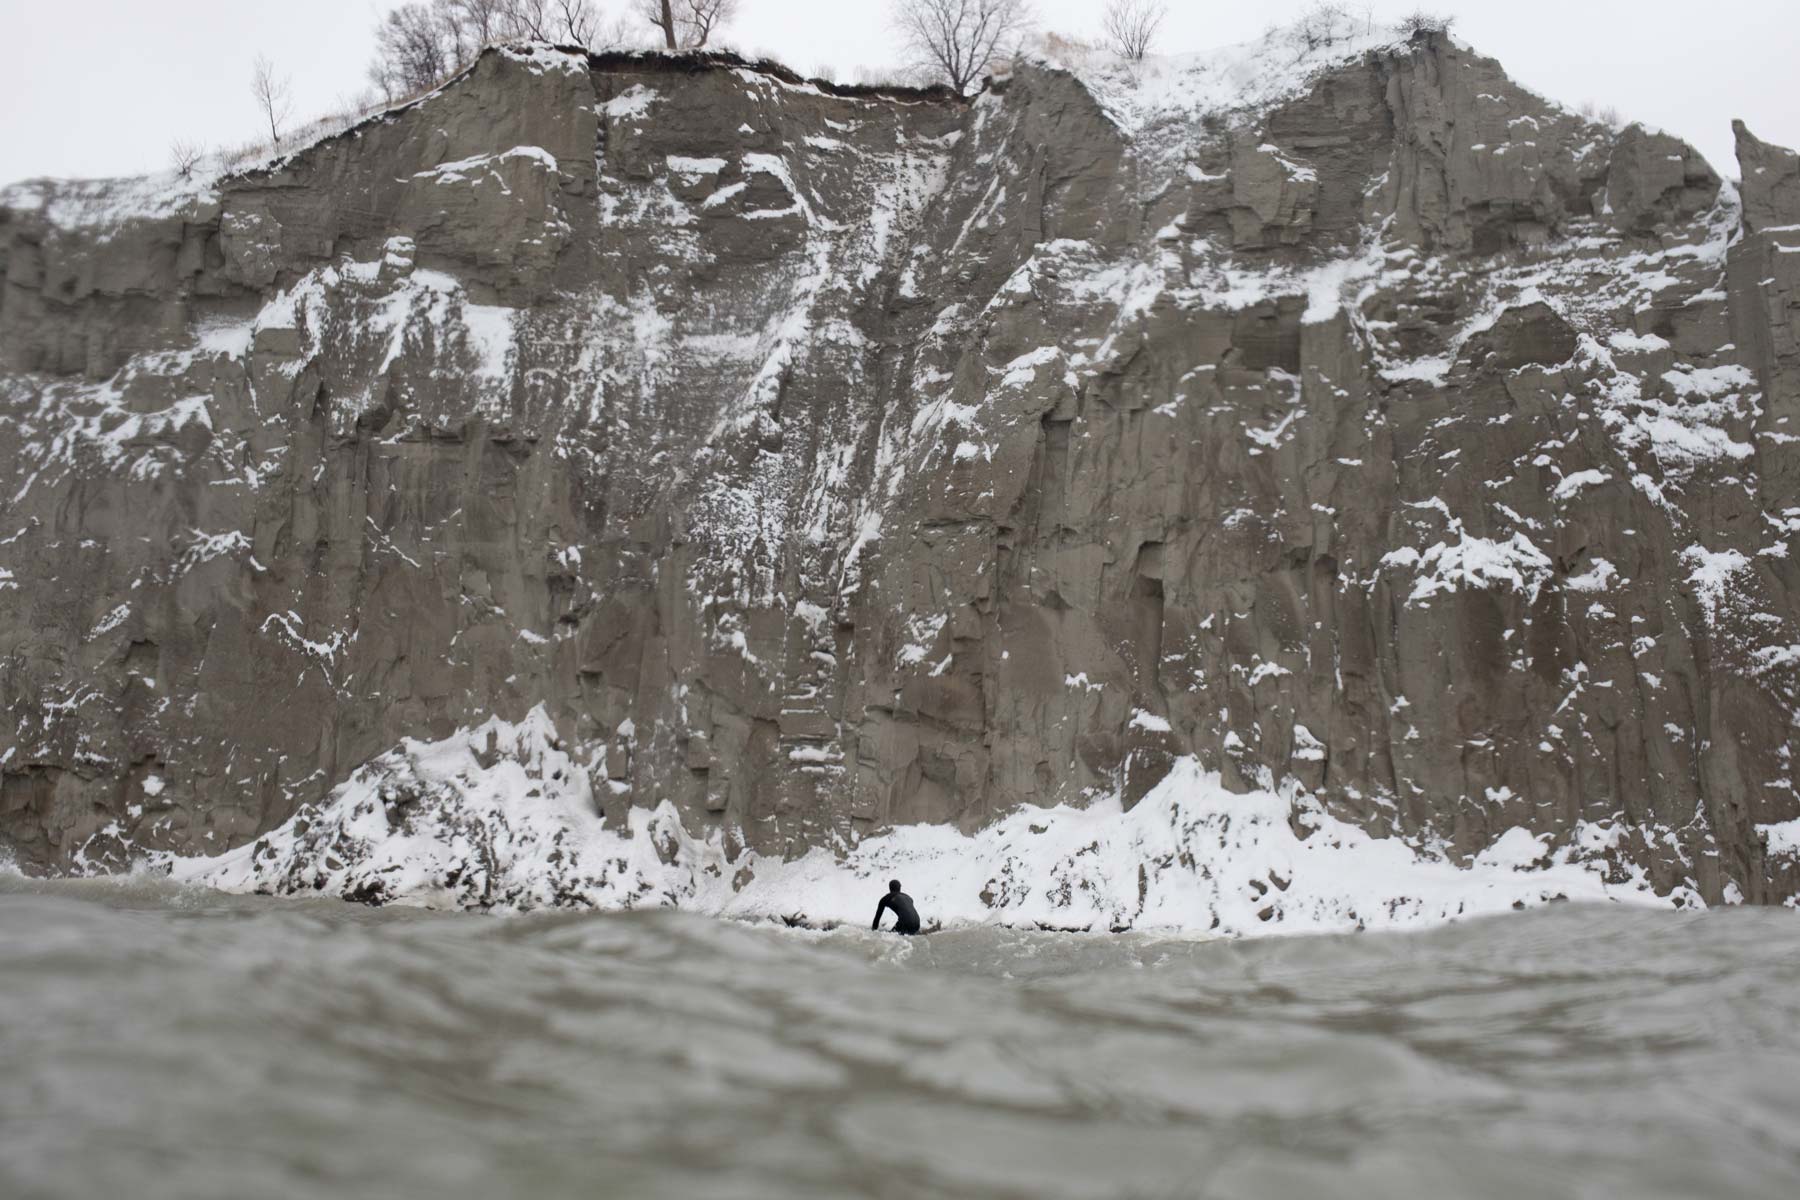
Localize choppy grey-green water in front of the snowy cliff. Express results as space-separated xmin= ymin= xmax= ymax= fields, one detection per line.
xmin=0 ymin=878 xmax=1800 ymax=1200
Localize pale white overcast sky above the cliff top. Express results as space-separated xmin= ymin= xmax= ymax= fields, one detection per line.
xmin=0 ymin=0 xmax=1800 ymax=182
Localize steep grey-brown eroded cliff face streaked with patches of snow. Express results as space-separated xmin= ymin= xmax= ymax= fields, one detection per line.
xmin=0 ymin=28 xmax=1800 ymax=901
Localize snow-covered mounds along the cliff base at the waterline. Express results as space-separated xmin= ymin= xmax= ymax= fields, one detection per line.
xmin=155 ymin=709 xmax=1699 ymax=936
